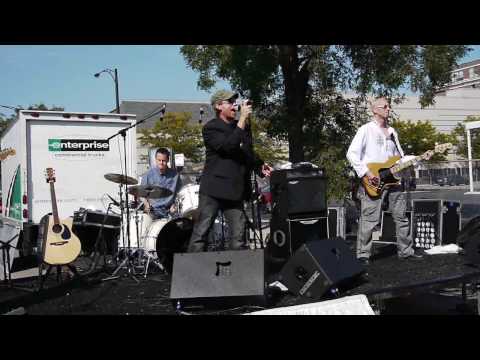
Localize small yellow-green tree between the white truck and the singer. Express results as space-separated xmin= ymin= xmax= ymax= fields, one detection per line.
xmin=139 ymin=112 xmax=203 ymax=162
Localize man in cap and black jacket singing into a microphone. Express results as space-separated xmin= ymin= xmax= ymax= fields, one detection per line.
xmin=188 ymin=90 xmax=272 ymax=252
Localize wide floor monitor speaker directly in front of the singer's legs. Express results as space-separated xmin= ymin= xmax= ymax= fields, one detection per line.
xmin=170 ymin=249 xmax=266 ymax=308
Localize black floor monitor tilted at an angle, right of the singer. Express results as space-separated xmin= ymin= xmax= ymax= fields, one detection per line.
xmin=278 ymin=238 xmax=365 ymax=299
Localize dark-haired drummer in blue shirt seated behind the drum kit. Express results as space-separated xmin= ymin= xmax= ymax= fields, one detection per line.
xmin=141 ymin=148 xmax=182 ymax=220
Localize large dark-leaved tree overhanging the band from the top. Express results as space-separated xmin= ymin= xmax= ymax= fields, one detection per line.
xmin=181 ymin=45 xmax=469 ymax=162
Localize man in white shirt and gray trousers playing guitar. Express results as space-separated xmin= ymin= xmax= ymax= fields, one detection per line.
xmin=347 ymin=97 xmax=422 ymax=265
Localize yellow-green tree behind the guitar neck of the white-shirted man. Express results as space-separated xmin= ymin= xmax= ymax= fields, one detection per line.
xmin=391 ymin=119 xmax=458 ymax=162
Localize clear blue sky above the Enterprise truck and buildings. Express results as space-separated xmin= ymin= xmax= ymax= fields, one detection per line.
xmin=0 ymin=45 xmax=480 ymax=115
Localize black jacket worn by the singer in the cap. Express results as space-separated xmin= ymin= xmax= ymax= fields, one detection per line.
xmin=200 ymin=118 xmax=263 ymax=201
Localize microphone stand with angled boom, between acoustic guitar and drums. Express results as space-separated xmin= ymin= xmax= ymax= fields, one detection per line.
xmin=103 ymin=118 xmax=153 ymax=283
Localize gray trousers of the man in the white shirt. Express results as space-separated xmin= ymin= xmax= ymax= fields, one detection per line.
xmin=357 ymin=186 xmax=413 ymax=259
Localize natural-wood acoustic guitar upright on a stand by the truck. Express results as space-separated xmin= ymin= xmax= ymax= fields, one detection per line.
xmin=42 ymin=168 xmax=82 ymax=265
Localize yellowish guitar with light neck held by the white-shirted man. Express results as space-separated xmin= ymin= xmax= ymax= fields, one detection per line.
xmin=362 ymin=143 xmax=453 ymax=198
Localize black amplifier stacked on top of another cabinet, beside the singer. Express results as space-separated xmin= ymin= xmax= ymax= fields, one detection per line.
xmin=270 ymin=167 xmax=327 ymax=219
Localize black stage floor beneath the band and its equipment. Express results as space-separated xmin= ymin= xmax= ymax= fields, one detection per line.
xmin=0 ymin=245 xmax=480 ymax=315
